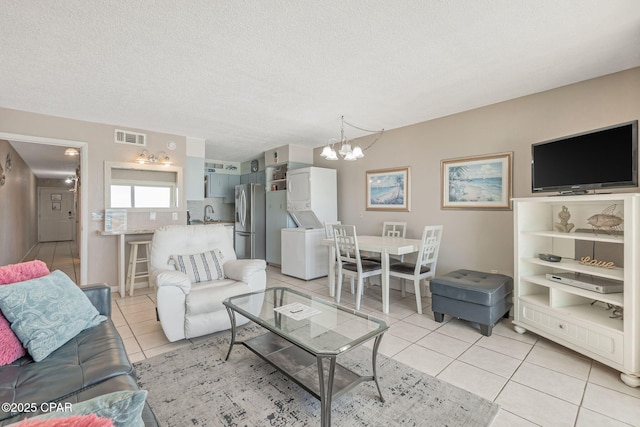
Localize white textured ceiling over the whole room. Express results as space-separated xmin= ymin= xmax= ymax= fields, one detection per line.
xmin=0 ymin=0 xmax=640 ymax=166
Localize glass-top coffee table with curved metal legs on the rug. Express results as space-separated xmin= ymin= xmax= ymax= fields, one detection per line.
xmin=224 ymin=287 xmax=389 ymax=426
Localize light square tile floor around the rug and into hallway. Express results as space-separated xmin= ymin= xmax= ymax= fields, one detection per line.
xmin=32 ymin=246 xmax=640 ymax=427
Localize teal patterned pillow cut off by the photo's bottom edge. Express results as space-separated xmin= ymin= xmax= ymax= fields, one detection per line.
xmin=10 ymin=390 xmax=147 ymax=427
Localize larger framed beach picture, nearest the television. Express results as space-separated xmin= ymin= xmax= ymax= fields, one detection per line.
xmin=440 ymin=152 xmax=513 ymax=209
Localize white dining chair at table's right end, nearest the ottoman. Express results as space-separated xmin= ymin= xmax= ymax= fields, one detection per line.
xmin=389 ymin=225 xmax=443 ymax=314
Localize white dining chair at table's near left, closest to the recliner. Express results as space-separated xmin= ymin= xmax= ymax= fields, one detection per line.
xmin=333 ymin=225 xmax=382 ymax=310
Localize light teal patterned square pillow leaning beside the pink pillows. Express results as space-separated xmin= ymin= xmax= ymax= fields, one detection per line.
xmin=0 ymin=270 xmax=106 ymax=362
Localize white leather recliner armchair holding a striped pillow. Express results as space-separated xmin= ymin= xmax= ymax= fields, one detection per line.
xmin=150 ymin=225 xmax=267 ymax=342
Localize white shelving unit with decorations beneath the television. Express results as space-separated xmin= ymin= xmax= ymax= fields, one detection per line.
xmin=513 ymin=193 xmax=640 ymax=387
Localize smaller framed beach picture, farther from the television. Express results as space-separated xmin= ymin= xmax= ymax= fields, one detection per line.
xmin=367 ymin=167 xmax=410 ymax=211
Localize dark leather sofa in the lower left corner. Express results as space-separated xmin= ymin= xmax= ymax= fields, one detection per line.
xmin=0 ymin=285 xmax=158 ymax=426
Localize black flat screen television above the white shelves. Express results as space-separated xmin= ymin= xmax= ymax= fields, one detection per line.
xmin=531 ymin=120 xmax=638 ymax=194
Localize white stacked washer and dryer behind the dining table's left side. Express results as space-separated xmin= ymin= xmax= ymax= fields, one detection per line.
xmin=281 ymin=167 xmax=338 ymax=280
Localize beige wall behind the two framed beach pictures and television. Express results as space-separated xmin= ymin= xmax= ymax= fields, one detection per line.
xmin=314 ymin=68 xmax=640 ymax=275
